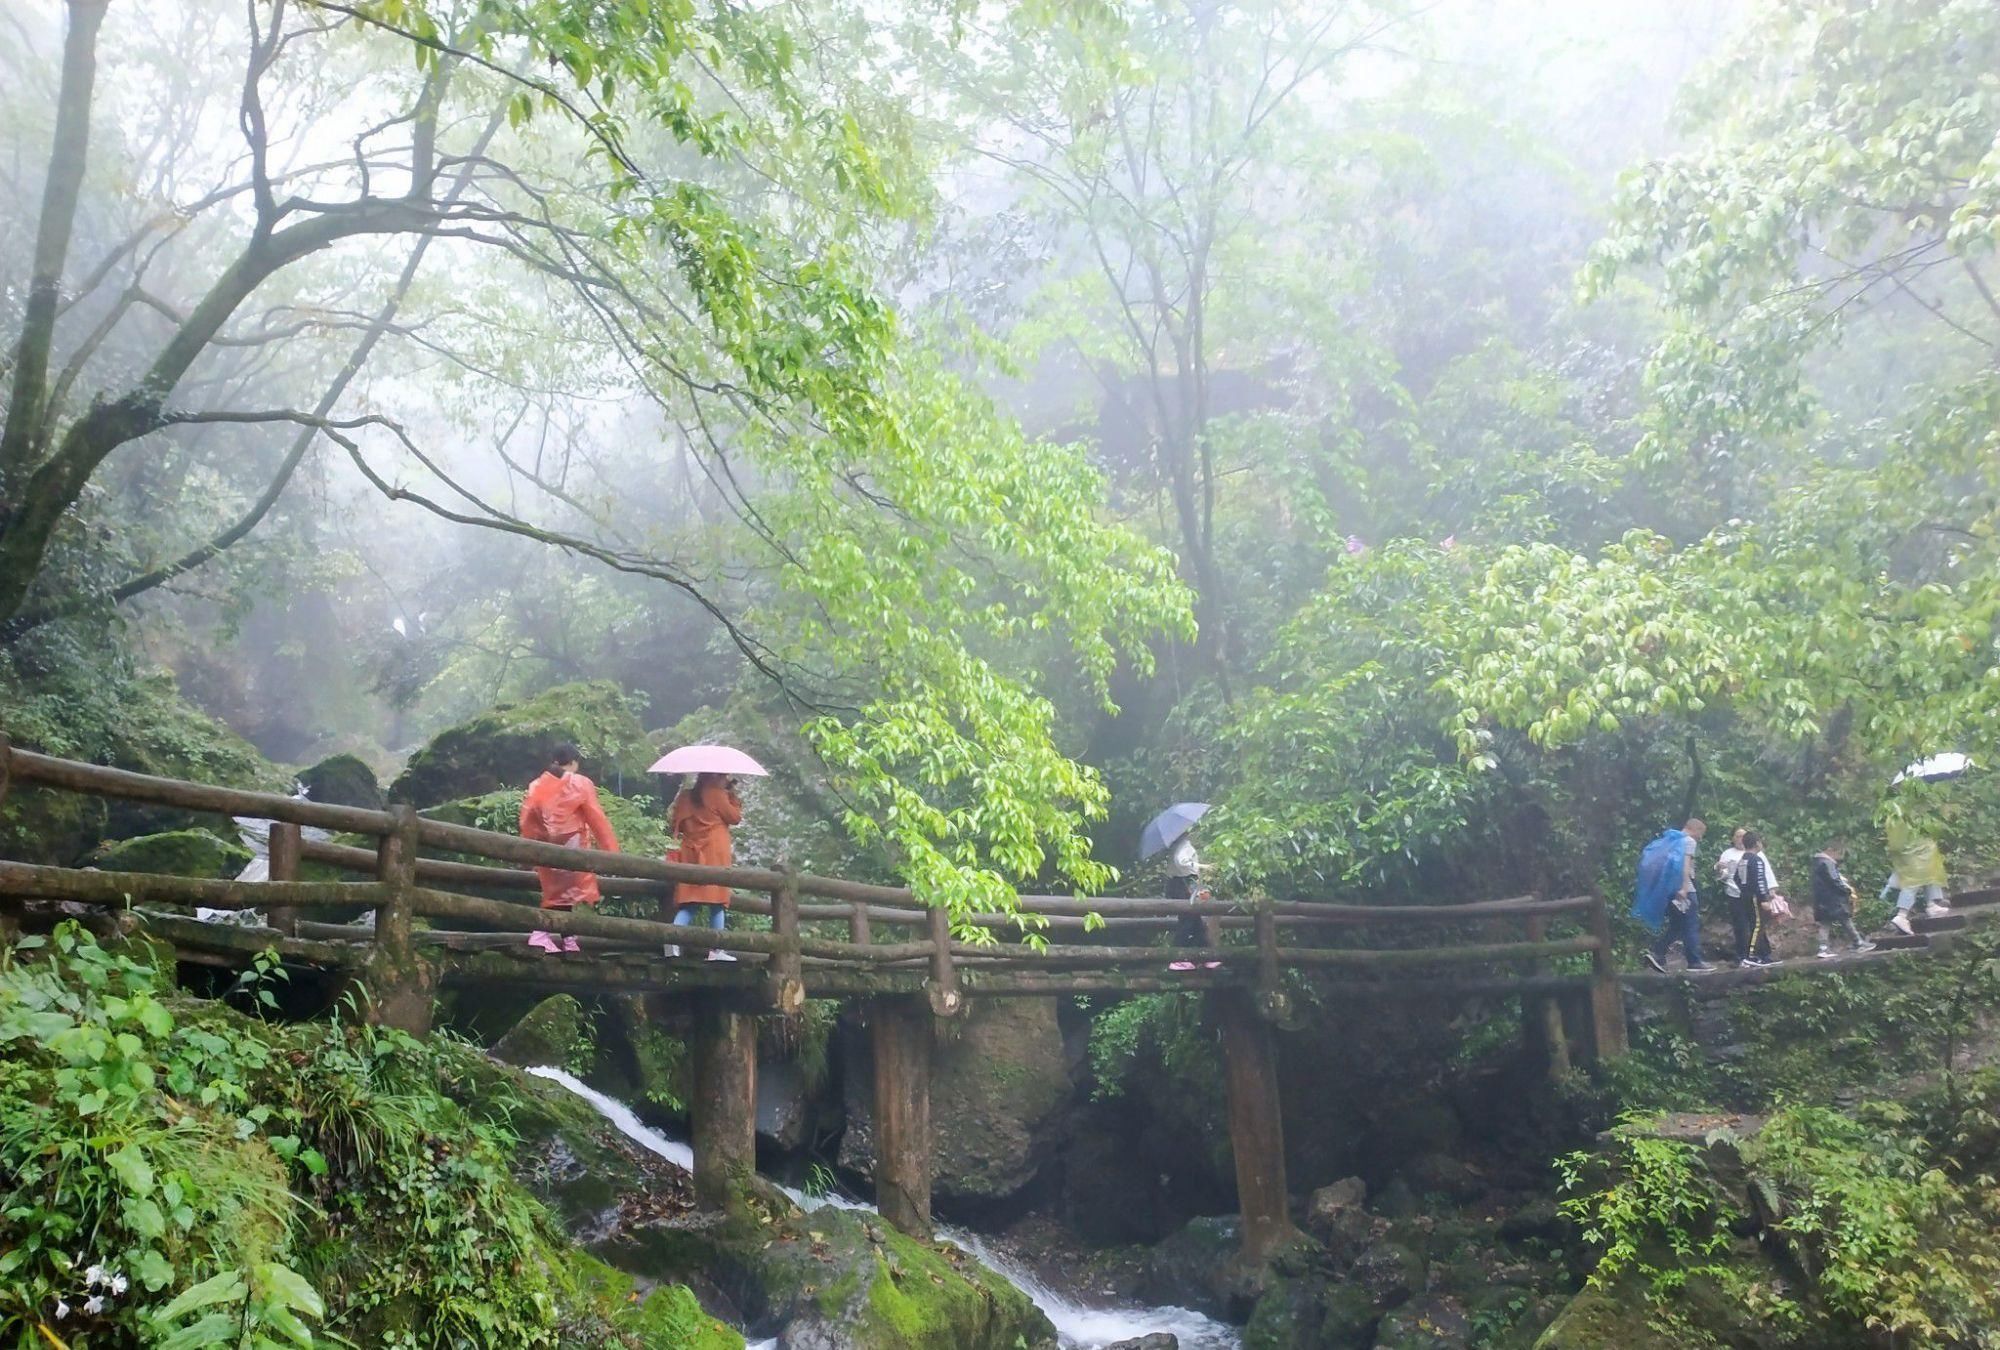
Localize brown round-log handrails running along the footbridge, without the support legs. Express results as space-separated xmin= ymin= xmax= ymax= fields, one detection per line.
xmin=0 ymin=736 xmax=1616 ymax=1014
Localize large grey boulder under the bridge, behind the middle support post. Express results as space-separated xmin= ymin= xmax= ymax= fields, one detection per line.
xmin=840 ymin=998 xmax=1070 ymax=1200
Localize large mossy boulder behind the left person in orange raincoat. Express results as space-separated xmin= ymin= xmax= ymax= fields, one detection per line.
xmin=388 ymin=680 xmax=652 ymax=806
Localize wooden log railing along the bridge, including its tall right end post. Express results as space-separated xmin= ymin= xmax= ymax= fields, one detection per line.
xmin=0 ymin=738 xmax=1624 ymax=1048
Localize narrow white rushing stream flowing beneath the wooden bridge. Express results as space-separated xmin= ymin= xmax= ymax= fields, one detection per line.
xmin=528 ymin=1068 xmax=1242 ymax=1350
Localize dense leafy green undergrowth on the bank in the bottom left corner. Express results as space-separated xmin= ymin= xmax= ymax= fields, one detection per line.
xmin=0 ymin=926 xmax=720 ymax=1350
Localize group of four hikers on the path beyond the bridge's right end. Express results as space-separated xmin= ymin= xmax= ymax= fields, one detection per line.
xmin=1632 ymin=820 xmax=1950 ymax=974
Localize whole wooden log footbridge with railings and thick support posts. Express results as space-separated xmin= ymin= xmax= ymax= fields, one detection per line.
xmin=0 ymin=738 xmax=1626 ymax=1258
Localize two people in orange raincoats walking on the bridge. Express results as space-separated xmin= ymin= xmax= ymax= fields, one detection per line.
xmin=520 ymin=744 xmax=744 ymax=960
